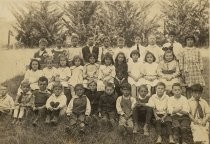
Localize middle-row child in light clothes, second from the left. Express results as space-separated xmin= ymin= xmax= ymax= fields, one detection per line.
xmin=42 ymin=57 xmax=57 ymax=90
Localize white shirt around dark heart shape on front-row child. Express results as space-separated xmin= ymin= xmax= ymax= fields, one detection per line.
xmin=46 ymin=93 xmax=67 ymax=108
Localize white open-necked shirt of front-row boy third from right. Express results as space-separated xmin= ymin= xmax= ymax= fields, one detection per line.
xmin=148 ymin=94 xmax=169 ymax=114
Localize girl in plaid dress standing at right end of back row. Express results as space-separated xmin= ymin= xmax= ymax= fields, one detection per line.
xmin=179 ymin=35 xmax=205 ymax=98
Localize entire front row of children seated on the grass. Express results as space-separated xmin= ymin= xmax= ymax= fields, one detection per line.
xmin=1 ymin=77 xmax=210 ymax=144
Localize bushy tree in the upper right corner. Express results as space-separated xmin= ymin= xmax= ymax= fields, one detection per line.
xmin=161 ymin=0 xmax=209 ymax=45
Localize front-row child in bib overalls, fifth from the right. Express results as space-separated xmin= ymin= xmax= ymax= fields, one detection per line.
xmin=116 ymin=83 xmax=136 ymax=135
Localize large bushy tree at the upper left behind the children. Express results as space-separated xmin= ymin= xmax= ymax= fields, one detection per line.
xmin=11 ymin=1 xmax=63 ymax=47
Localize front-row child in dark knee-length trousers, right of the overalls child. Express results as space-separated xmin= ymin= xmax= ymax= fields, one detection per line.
xmin=133 ymin=85 xmax=153 ymax=136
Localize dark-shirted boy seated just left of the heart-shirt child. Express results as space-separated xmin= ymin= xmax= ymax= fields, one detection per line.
xmin=31 ymin=76 xmax=51 ymax=126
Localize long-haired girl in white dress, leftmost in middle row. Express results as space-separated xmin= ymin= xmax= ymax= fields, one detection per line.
xmin=24 ymin=59 xmax=43 ymax=90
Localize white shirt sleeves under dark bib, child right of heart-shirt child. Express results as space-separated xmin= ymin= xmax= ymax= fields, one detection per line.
xmin=66 ymin=95 xmax=91 ymax=115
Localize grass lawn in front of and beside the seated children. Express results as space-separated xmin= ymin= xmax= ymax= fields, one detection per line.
xmin=0 ymin=57 xmax=209 ymax=144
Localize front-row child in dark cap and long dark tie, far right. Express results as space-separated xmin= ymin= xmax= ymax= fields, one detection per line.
xmin=188 ymin=84 xmax=210 ymax=144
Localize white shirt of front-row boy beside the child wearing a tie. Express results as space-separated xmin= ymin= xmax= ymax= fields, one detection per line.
xmin=168 ymin=95 xmax=190 ymax=116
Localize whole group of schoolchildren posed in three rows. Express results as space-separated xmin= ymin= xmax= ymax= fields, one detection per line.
xmin=0 ymin=32 xmax=210 ymax=144
